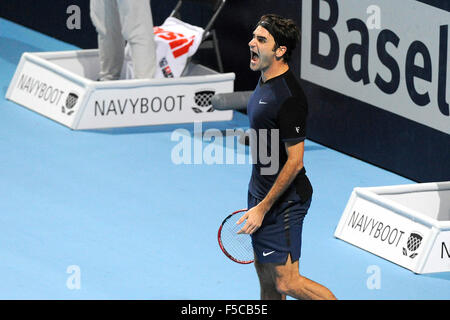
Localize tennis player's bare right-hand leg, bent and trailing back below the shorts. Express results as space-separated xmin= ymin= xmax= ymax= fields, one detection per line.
xmin=273 ymin=255 xmax=336 ymax=300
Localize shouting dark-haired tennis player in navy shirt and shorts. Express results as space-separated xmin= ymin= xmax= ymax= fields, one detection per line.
xmin=237 ymin=14 xmax=336 ymax=300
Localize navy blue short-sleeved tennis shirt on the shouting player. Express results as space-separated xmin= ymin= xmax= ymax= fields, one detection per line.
xmin=247 ymin=70 xmax=313 ymax=203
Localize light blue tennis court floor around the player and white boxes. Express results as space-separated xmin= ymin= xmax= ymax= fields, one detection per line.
xmin=0 ymin=19 xmax=450 ymax=300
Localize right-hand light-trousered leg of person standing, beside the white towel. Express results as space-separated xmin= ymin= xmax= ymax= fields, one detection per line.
xmin=118 ymin=0 xmax=156 ymax=79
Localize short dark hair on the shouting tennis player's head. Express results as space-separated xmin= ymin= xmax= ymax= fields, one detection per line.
xmin=257 ymin=14 xmax=300 ymax=62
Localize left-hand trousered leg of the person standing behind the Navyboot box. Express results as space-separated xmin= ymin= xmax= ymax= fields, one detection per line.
xmin=90 ymin=0 xmax=125 ymax=81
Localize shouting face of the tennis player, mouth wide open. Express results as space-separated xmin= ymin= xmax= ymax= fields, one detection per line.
xmin=248 ymin=26 xmax=275 ymax=72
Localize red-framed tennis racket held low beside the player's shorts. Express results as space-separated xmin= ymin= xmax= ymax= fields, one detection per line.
xmin=217 ymin=209 xmax=255 ymax=264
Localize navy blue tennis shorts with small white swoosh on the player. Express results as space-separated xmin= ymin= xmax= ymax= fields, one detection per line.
xmin=248 ymin=192 xmax=311 ymax=264
